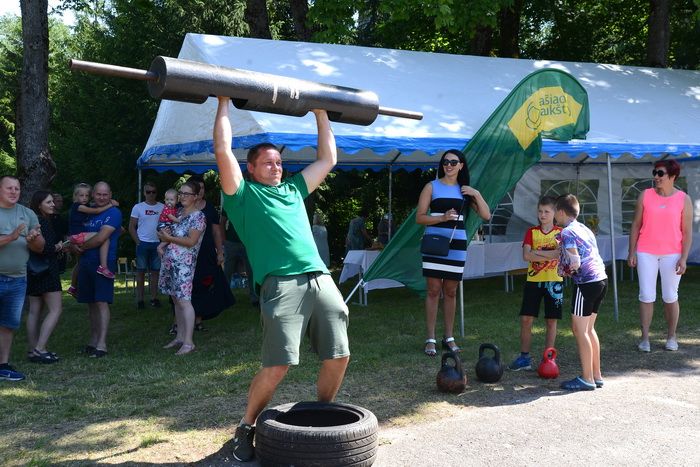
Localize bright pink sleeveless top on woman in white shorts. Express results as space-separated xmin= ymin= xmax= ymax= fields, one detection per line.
xmin=637 ymin=188 xmax=685 ymax=255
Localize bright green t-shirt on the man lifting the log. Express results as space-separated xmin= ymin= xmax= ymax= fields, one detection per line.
xmin=223 ymin=173 xmax=328 ymax=284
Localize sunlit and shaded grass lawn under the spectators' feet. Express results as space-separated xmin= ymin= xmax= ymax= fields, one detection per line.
xmin=0 ymin=267 xmax=700 ymax=465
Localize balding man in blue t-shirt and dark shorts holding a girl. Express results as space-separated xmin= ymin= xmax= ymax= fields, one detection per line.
xmin=77 ymin=182 xmax=122 ymax=358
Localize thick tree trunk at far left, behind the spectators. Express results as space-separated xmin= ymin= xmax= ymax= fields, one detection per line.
xmin=16 ymin=0 xmax=56 ymax=204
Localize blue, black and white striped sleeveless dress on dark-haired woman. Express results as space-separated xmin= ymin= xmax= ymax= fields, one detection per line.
xmin=423 ymin=180 xmax=469 ymax=281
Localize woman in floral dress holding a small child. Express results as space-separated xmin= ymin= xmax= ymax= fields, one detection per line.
xmin=158 ymin=181 xmax=206 ymax=355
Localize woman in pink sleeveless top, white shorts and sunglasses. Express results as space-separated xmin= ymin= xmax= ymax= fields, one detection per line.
xmin=627 ymin=160 xmax=693 ymax=352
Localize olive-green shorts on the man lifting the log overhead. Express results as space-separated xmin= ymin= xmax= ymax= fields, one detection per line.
xmin=260 ymin=272 xmax=350 ymax=367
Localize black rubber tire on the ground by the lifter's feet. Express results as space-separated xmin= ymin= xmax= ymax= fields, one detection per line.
xmin=255 ymin=402 xmax=378 ymax=467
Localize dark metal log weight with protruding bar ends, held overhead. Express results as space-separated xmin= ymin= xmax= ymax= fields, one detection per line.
xmin=69 ymin=56 xmax=423 ymax=125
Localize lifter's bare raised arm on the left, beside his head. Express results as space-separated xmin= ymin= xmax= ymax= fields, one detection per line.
xmin=214 ymin=96 xmax=243 ymax=195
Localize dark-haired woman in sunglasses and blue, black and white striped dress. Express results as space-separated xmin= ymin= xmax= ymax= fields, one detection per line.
xmin=416 ymin=149 xmax=491 ymax=357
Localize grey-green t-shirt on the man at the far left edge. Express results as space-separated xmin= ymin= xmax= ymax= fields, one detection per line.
xmin=0 ymin=204 xmax=39 ymax=277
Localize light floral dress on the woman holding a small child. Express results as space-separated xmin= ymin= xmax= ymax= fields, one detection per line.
xmin=158 ymin=211 xmax=207 ymax=300
